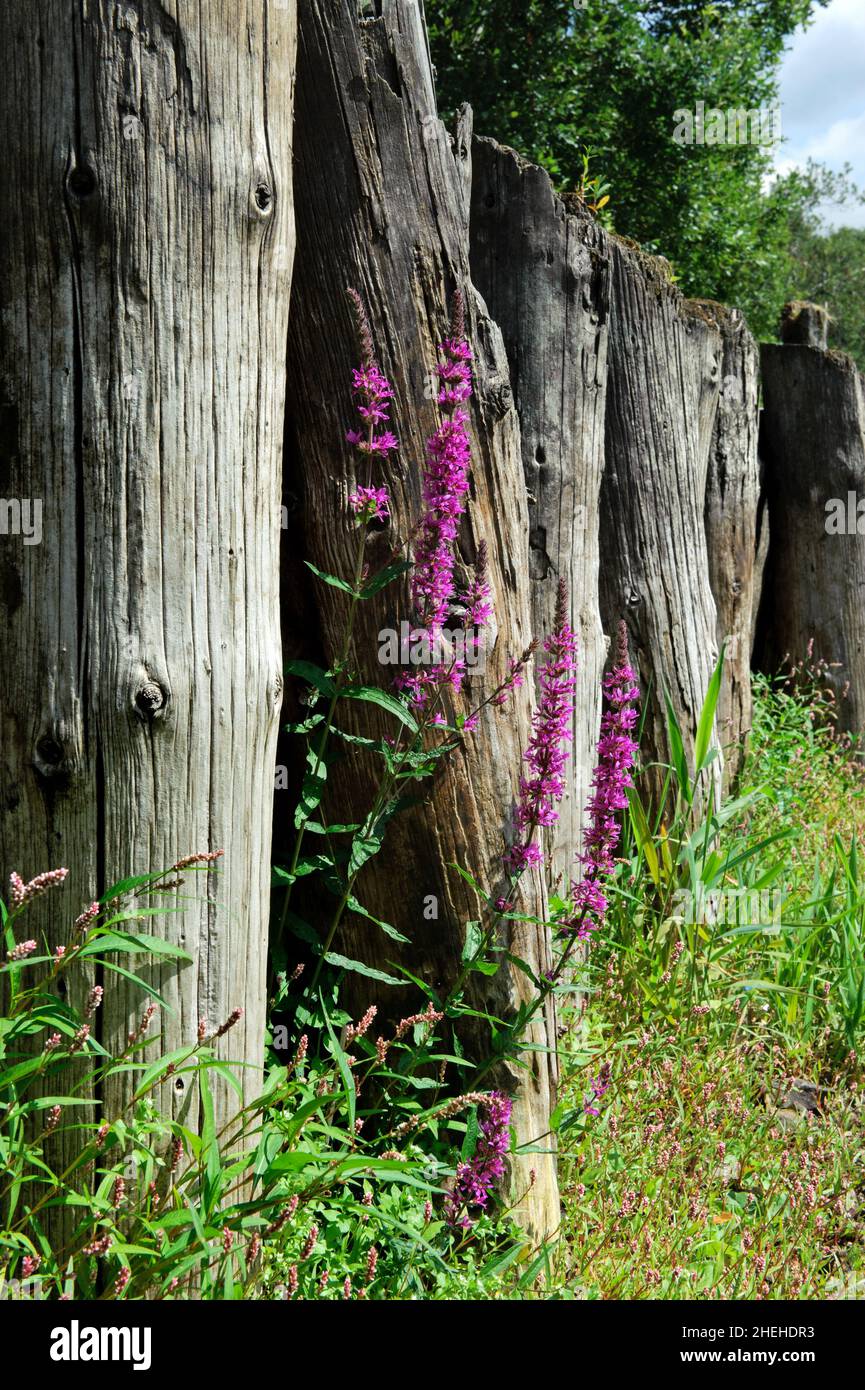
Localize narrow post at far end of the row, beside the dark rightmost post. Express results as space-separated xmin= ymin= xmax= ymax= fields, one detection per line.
xmin=701 ymin=300 xmax=759 ymax=788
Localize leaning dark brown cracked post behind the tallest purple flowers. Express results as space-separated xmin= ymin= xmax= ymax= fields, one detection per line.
xmin=285 ymin=0 xmax=559 ymax=1232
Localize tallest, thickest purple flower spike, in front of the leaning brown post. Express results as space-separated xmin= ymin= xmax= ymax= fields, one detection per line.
xmin=412 ymin=292 xmax=471 ymax=637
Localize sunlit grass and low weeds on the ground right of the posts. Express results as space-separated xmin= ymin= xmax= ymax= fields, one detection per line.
xmin=548 ymin=660 xmax=865 ymax=1300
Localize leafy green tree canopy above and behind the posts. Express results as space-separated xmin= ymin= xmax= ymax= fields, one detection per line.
xmin=430 ymin=0 xmax=861 ymax=340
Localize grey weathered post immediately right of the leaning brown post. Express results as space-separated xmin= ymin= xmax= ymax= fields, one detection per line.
xmin=471 ymin=139 xmax=609 ymax=888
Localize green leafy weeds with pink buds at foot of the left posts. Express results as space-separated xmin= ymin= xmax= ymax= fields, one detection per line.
xmin=0 ymin=866 xmax=528 ymax=1300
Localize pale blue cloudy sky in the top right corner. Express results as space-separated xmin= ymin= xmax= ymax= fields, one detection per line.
xmin=777 ymin=0 xmax=865 ymax=227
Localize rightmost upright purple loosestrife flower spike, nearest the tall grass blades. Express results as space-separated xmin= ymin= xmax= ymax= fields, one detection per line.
xmin=569 ymin=623 xmax=640 ymax=941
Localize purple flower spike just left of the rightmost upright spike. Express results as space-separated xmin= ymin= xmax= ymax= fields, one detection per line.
xmin=505 ymin=580 xmax=577 ymax=873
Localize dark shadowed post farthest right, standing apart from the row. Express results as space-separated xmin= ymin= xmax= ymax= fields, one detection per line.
xmin=755 ymin=343 xmax=865 ymax=733
